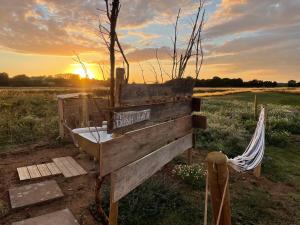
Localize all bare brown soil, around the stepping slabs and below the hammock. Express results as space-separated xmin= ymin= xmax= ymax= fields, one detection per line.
xmin=0 ymin=144 xmax=295 ymax=225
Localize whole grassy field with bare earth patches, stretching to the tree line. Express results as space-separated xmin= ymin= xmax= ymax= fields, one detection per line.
xmin=0 ymin=89 xmax=300 ymax=225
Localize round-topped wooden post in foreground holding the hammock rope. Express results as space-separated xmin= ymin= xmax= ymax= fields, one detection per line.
xmin=206 ymin=152 xmax=231 ymax=225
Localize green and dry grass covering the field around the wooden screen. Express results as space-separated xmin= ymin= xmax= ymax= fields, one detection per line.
xmin=0 ymin=89 xmax=300 ymax=225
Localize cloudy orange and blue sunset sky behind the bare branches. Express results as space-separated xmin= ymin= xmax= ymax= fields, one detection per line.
xmin=0 ymin=0 xmax=300 ymax=83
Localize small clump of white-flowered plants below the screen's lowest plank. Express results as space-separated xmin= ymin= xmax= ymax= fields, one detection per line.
xmin=173 ymin=164 xmax=205 ymax=190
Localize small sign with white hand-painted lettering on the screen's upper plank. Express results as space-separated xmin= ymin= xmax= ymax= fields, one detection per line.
xmin=114 ymin=109 xmax=151 ymax=129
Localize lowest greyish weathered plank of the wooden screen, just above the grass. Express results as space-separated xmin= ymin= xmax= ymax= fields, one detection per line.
xmin=111 ymin=133 xmax=193 ymax=202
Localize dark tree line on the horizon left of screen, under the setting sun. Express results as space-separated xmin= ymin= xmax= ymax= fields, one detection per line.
xmin=0 ymin=72 xmax=108 ymax=87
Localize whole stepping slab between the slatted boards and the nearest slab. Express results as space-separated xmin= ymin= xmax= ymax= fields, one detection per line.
xmin=9 ymin=180 xmax=64 ymax=209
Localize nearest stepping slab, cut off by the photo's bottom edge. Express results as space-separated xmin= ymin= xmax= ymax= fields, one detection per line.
xmin=12 ymin=209 xmax=79 ymax=225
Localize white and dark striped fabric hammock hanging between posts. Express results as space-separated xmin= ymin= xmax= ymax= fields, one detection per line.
xmin=228 ymin=108 xmax=265 ymax=172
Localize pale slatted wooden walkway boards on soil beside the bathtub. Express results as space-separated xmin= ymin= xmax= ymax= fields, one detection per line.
xmin=17 ymin=156 xmax=87 ymax=180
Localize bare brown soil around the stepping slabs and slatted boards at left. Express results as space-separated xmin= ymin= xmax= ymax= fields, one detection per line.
xmin=0 ymin=145 xmax=99 ymax=225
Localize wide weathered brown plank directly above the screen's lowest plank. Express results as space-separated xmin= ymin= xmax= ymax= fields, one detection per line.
xmin=101 ymin=116 xmax=192 ymax=176
